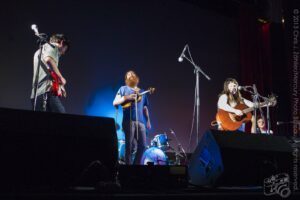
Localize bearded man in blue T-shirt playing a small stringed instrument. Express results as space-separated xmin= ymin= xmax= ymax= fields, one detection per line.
xmin=113 ymin=71 xmax=151 ymax=165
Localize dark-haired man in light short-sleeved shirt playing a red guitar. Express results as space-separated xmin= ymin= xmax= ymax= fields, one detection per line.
xmin=31 ymin=34 xmax=70 ymax=113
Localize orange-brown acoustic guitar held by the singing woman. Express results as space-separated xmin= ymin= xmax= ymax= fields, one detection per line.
xmin=216 ymin=96 xmax=277 ymax=131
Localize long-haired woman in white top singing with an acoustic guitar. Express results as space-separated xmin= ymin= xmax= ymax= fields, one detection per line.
xmin=217 ymin=78 xmax=254 ymax=132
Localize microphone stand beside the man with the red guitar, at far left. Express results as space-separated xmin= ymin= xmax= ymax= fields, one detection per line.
xmin=33 ymin=33 xmax=47 ymax=111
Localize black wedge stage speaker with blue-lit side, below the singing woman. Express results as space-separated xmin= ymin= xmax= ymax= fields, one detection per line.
xmin=188 ymin=130 xmax=293 ymax=187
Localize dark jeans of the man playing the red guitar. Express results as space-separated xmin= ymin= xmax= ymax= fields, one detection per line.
xmin=31 ymin=92 xmax=66 ymax=113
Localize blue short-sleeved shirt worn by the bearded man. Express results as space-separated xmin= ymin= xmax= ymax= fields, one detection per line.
xmin=117 ymin=86 xmax=149 ymax=123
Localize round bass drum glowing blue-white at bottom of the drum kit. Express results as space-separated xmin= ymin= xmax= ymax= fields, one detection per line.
xmin=141 ymin=147 xmax=169 ymax=165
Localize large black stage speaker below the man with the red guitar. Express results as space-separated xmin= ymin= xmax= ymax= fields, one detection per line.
xmin=0 ymin=108 xmax=118 ymax=191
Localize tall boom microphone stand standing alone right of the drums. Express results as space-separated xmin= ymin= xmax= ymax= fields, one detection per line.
xmin=182 ymin=45 xmax=211 ymax=150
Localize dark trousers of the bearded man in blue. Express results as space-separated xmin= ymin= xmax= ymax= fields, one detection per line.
xmin=122 ymin=121 xmax=146 ymax=165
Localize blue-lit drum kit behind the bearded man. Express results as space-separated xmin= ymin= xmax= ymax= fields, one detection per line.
xmin=118 ymin=130 xmax=186 ymax=165
